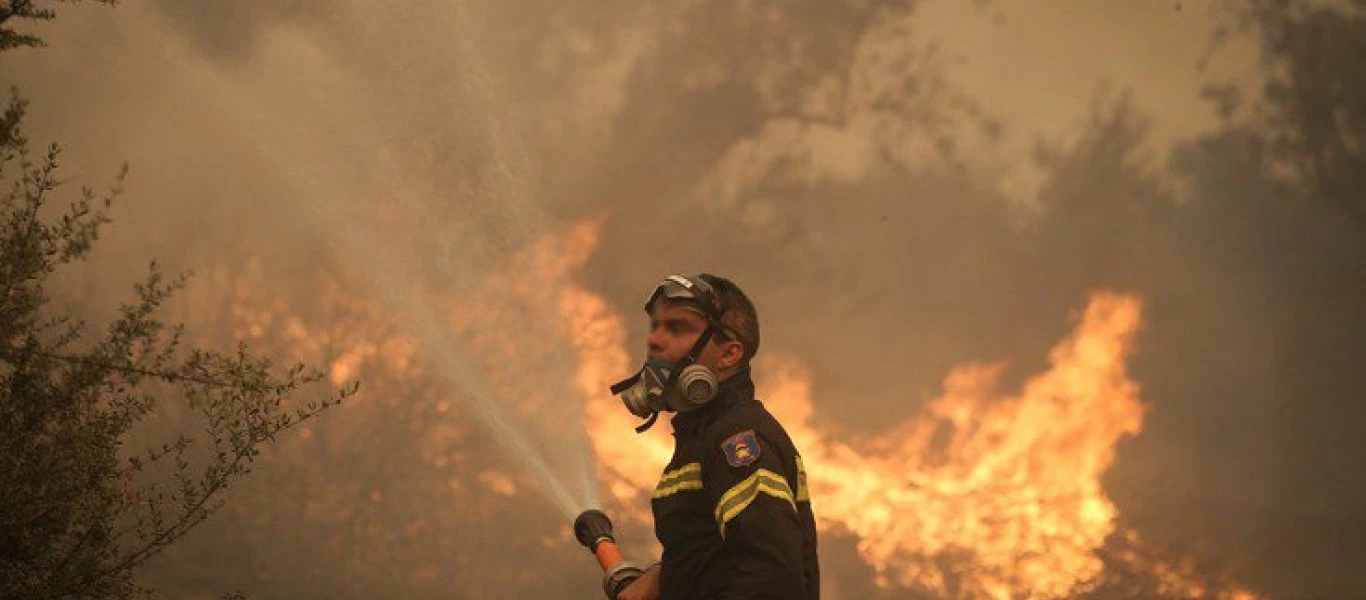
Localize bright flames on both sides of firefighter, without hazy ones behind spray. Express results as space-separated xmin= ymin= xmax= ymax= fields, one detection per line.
xmin=538 ymin=221 xmax=1257 ymax=600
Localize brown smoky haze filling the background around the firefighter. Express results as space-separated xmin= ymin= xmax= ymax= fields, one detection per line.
xmin=0 ymin=0 xmax=1366 ymax=599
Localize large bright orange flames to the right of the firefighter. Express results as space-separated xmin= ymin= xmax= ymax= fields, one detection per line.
xmin=768 ymin=294 xmax=1142 ymax=597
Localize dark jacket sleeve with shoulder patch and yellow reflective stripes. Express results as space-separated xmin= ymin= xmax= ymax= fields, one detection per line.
xmin=702 ymin=429 xmax=806 ymax=600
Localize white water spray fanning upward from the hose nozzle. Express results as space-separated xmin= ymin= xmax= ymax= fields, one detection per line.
xmin=153 ymin=4 xmax=597 ymax=518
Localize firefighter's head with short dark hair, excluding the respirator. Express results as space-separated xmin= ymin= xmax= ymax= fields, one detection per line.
xmin=645 ymin=273 xmax=759 ymax=381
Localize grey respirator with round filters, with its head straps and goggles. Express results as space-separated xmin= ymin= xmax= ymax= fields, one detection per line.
xmin=612 ymin=275 xmax=725 ymax=433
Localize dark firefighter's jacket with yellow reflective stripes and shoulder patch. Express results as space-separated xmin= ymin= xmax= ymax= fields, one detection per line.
xmin=650 ymin=369 xmax=821 ymax=600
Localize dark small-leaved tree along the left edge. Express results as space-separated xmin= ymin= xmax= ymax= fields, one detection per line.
xmin=0 ymin=0 xmax=358 ymax=599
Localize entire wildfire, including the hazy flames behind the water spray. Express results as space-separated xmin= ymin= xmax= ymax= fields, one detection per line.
xmin=189 ymin=220 xmax=1259 ymax=600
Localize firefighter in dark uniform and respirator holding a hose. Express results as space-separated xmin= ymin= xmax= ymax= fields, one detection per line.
xmin=612 ymin=273 xmax=820 ymax=600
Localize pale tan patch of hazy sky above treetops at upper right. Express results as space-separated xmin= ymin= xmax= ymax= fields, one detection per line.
xmin=915 ymin=0 xmax=1257 ymax=201
